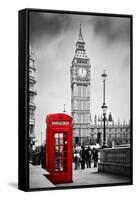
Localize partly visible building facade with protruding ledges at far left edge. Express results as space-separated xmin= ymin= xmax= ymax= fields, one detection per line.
xmin=29 ymin=48 xmax=37 ymax=159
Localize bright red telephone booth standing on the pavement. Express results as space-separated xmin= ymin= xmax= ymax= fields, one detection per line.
xmin=46 ymin=113 xmax=73 ymax=183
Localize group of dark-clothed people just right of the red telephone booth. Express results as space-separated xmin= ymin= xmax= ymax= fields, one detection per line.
xmin=73 ymin=146 xmax=98 ymax=170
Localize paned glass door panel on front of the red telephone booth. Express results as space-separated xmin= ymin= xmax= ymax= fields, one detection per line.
xmin=54 ymin=132 xmax=68 ymax=173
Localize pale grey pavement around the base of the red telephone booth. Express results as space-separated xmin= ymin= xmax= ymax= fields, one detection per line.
xmin=29 ymin=162 xmax=130 ymax=189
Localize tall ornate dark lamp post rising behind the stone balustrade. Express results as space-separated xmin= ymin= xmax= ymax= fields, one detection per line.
xmin=101 ymin=70 xmax=108 ymax=148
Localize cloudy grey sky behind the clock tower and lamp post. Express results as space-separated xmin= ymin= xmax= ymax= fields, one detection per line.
xmin=30 ymin=12 xmax=130 ymax=145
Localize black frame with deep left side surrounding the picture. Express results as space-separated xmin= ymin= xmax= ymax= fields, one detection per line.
xmin=18 ymin=8 xmax=133 ymax=191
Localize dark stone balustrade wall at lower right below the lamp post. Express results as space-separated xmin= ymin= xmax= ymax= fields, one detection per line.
xmin=98 ymin=147 xmax=131 ymax=176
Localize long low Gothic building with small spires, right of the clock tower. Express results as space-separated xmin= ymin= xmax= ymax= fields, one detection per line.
xmin=88 ymin=115 xmax=130 ymax=147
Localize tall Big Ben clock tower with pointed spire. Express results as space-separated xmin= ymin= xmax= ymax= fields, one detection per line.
xmin=70 ymin=24 xmax=91 ymax=145
